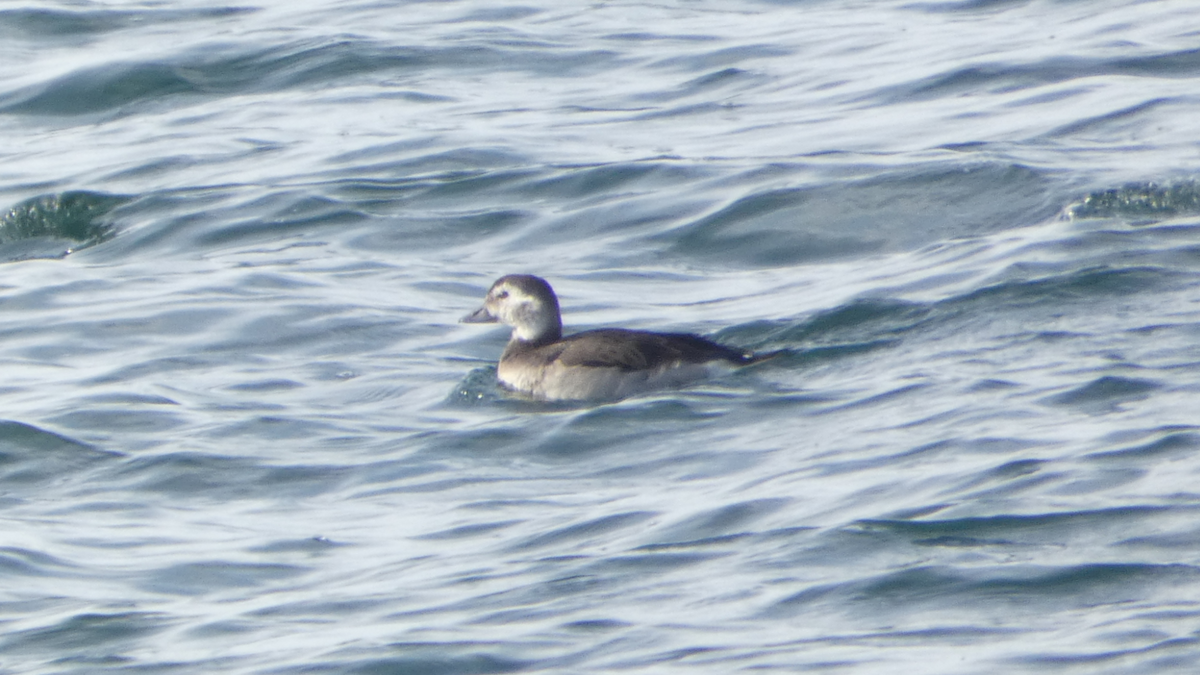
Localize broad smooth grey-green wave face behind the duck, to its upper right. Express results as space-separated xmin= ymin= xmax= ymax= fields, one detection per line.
xmin=655 ymin=165 xmax=1057 ymax=267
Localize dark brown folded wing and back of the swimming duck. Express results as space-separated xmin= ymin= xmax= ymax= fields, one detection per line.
xmin=556 ymin=328 xmax=750 ymax=370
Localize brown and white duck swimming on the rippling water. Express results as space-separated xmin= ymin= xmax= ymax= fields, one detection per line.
xmin=461 ymin=274 xmax=769 ymax=401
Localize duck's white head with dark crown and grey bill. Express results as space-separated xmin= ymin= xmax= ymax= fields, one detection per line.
xmin=462 ymin=274 xmax=563 ymax=345
